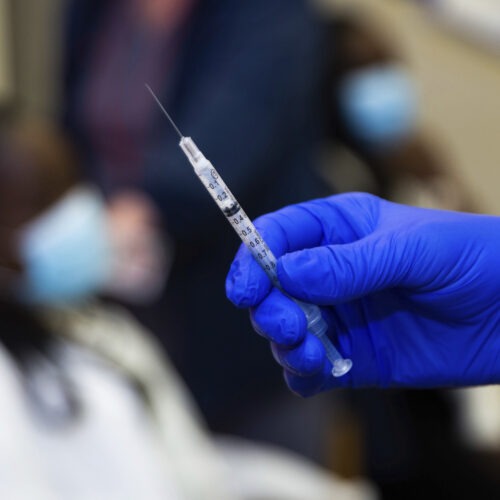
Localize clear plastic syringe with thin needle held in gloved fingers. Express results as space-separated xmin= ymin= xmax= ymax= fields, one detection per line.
xmin=146 ymin=84 xmax=352 ymax=377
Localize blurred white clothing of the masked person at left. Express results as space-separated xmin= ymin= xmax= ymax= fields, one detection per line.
xmin=0 ymin=306 xmax=375 ymax=500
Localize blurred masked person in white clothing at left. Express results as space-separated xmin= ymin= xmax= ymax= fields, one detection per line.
xmin=0 ymin=119 xmax=374 ymax=500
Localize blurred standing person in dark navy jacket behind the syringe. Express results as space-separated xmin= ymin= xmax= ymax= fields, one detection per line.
xmin=65 ymin=0 xmax=336 ymax=460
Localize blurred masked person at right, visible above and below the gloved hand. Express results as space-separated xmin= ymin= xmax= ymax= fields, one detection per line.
xmin=316 ymin=14 xmax=499 ymax=499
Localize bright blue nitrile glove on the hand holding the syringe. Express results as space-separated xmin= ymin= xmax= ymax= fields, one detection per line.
xmin=226 ymin=193 xmax=500 ymax=396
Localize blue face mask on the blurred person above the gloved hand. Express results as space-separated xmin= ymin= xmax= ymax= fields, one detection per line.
xmin=339 ymin=65 xmax=417 ymax=148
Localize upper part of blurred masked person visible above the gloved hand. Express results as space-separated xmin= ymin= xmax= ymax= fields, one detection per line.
xmin=322 ymin=14 xmax=474 ymax=211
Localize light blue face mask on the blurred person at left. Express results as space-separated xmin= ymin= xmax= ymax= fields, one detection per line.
xmin=19 ymin=187 xmax=110 ymax=305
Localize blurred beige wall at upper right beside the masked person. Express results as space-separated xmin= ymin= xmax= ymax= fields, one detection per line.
xmin=317 ymin=0 xmax=500 ymax=214
